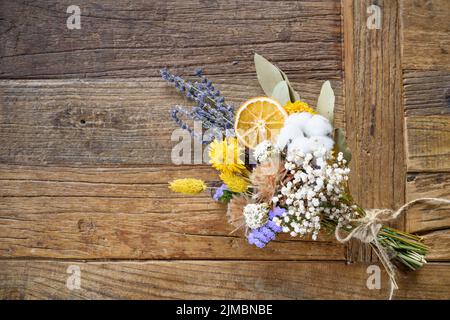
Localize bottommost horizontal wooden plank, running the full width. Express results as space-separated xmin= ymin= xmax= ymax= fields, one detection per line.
xmin=0 ymin=260 xmax=450 ymax=299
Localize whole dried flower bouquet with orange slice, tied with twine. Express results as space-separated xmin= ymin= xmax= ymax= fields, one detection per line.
xmin=161 ymin=54 xmax=444 ymax=296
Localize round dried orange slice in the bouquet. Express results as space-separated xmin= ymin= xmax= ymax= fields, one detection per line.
xmin=234 ymin=97 xmax=288 ymax=149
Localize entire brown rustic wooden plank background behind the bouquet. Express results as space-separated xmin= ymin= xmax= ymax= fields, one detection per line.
xmin=0 ymin=0 xmax=450 ymax=299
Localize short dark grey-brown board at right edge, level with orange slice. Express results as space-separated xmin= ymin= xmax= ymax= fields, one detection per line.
xmin=403 ymin=70 xmax=450 ymax=117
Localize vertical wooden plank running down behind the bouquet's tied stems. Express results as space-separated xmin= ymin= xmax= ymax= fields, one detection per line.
xmin=343 ymin=0 xmax=405 ymax=261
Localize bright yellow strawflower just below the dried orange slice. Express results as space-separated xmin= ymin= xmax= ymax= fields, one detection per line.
xmin=209 ymin=138 xmax=246 ymax=173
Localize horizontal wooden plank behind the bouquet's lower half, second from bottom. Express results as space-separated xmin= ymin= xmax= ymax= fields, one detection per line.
xmin=0 ymin=165 xmax=344 ymax=260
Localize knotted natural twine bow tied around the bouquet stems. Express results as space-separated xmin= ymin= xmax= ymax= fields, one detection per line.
xmin=335 ymin=198 xmax=450 ymax=300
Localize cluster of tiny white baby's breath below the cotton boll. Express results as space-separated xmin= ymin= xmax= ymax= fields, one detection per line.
xmin=275 ymin=151 xmax=354 ymax=240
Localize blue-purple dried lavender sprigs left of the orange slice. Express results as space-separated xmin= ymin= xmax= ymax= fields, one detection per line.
xmin=160 ymin=69 xmax=234 ymax=144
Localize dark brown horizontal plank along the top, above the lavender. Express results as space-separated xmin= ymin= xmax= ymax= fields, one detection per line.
xmin=0 ymin=0 xmax=342 ymax=80
